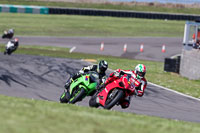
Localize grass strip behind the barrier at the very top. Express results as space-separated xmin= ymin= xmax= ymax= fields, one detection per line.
xmin=0 ymin=0 xmax=200 ymax=14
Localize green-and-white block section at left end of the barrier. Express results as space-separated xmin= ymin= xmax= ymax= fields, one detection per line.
xmin=0 ymin=4 xmax=49 ymax=14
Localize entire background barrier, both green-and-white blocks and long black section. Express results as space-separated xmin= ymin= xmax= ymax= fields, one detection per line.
xmin=0 ymin=4 xmax=200 ymax=20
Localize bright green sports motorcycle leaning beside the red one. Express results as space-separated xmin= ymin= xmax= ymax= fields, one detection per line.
xmin=60 ymin=71 xmax=99 ymax=104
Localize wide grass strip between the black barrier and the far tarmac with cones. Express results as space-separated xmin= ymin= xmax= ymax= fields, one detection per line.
xmin=0 ymin=13 xmax=185 ymax=37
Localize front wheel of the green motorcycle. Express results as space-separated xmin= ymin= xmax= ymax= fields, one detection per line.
xmin=69 ymin=87 xmax=86 ymax=104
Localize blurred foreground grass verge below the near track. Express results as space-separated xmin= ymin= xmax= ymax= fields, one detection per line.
xmin=0 ymin=95 xmax=200 ymax=133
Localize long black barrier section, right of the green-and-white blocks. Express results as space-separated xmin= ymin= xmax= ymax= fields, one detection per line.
xmin=49 ymin=8 xmax=200 ymax=20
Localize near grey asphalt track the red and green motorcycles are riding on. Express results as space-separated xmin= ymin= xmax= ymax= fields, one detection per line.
xmin=0 ymin=53 xmax=200 ymax=122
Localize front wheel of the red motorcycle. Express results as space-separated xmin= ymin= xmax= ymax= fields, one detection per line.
xmin=104 ymin=89 xmax=124 ymax=109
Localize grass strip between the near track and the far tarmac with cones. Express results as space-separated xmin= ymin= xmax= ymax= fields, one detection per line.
xmin=0 ymin=46 xmax=200 ymax=98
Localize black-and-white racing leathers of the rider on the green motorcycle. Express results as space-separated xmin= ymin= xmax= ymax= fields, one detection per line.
xmin=65 ymin=65 xmax=106 ymax=89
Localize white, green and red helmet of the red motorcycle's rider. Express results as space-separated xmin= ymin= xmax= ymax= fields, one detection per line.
xmin=135 ymin=64 xmax=146 ymax=79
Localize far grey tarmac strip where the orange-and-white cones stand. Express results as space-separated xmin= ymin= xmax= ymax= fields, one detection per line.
xmin=0 ymin=36 xmax=183 ymax=62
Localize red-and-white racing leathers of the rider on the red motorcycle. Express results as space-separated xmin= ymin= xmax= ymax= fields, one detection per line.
xmin=101 ymin=69 xmax=147 ymax=109
